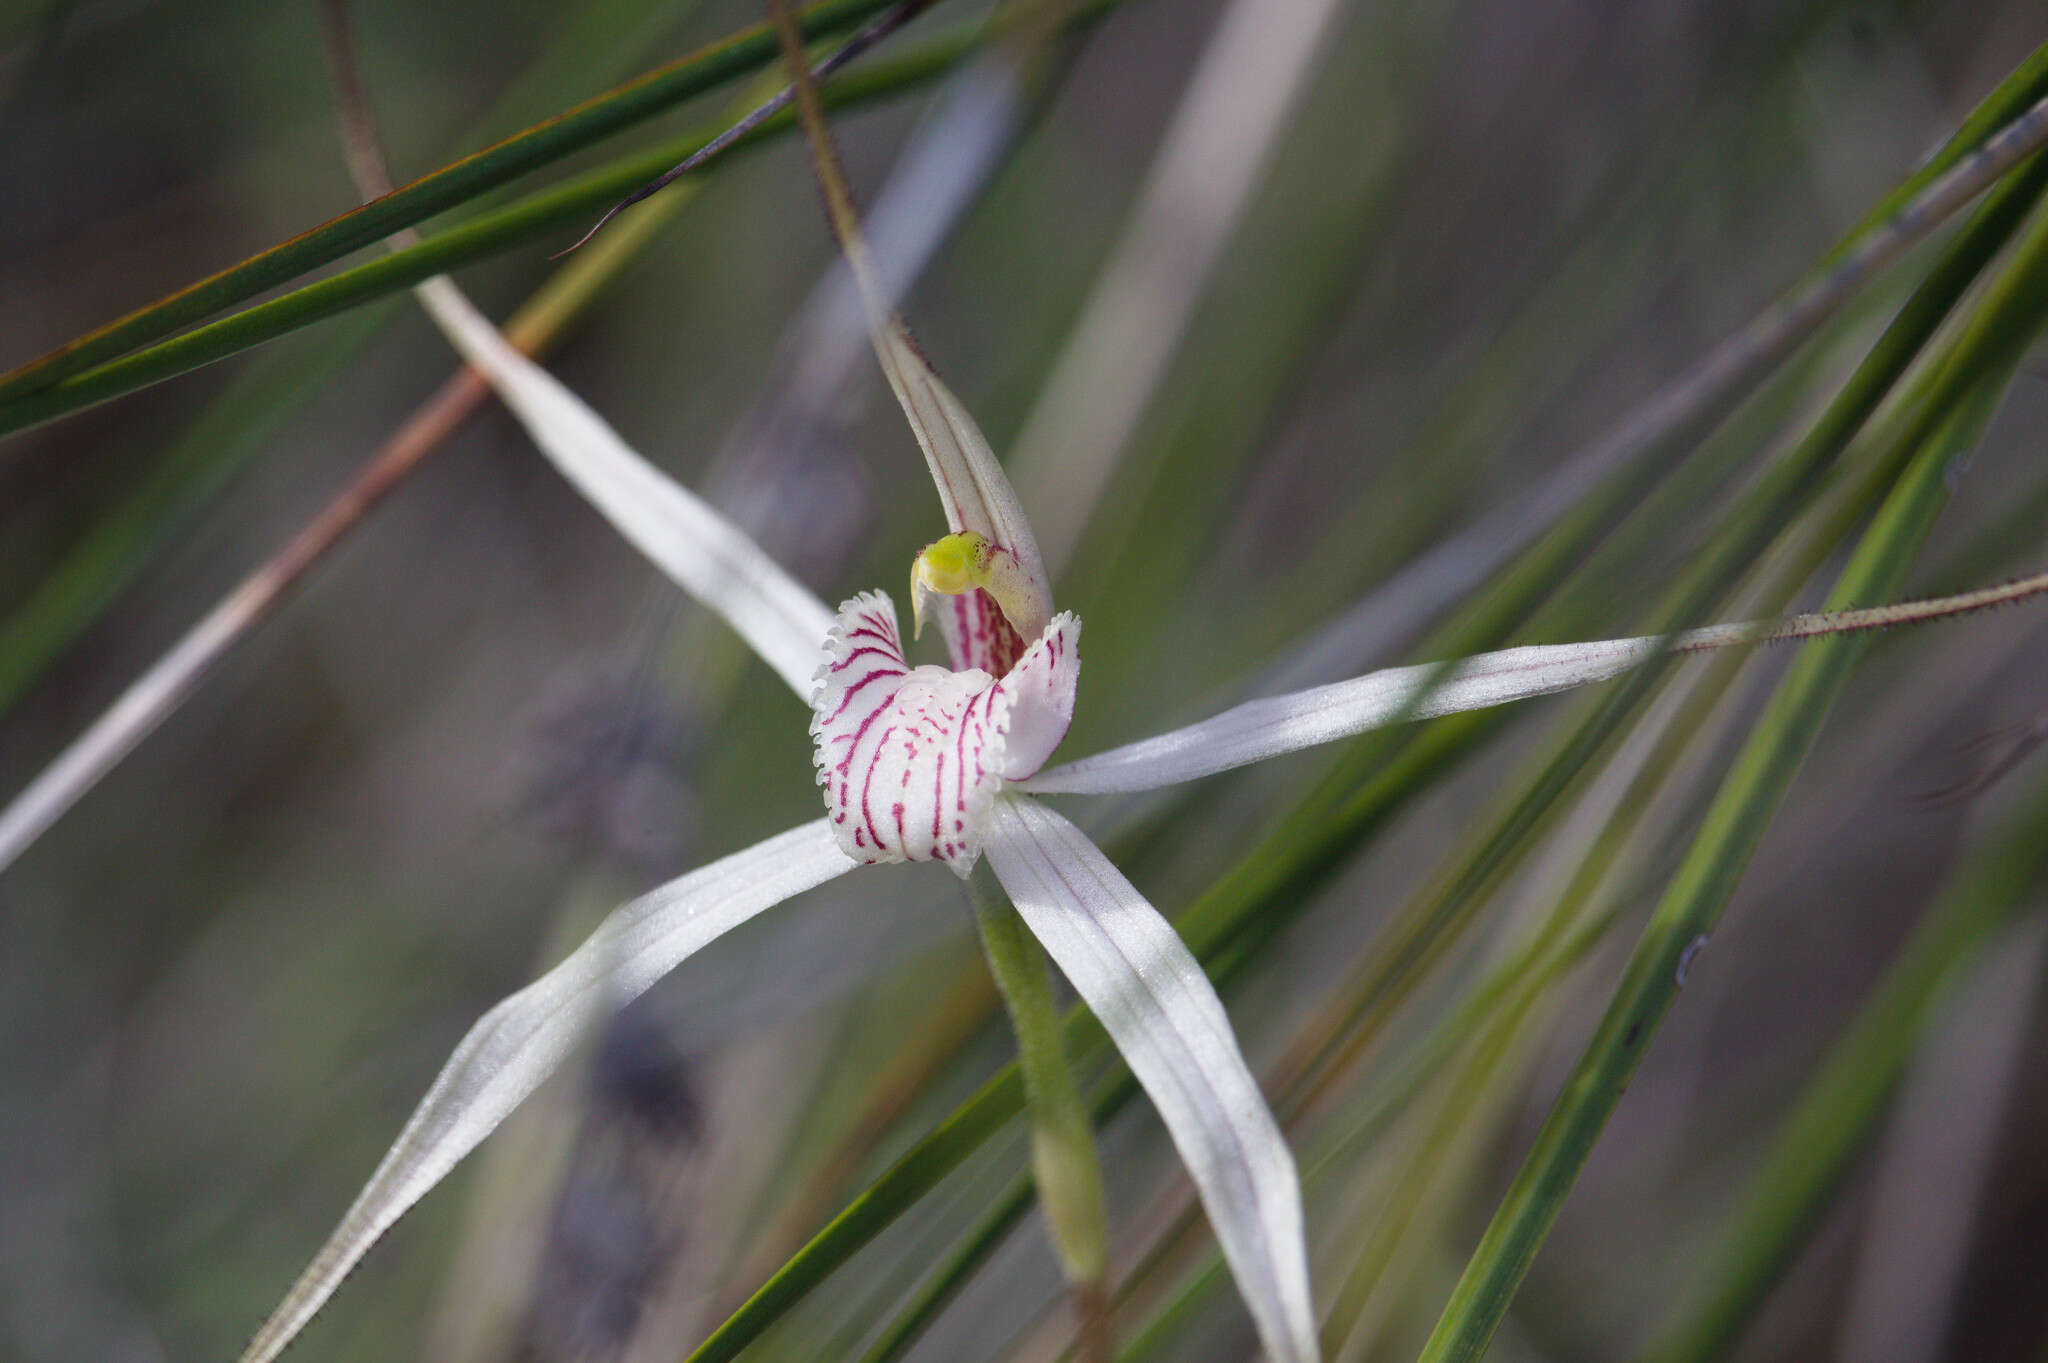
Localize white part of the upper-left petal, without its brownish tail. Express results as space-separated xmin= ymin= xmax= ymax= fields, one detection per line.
xmin=416 ymin=278 xmax=831 ymax=698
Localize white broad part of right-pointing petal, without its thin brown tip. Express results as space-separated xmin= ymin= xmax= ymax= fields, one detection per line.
xmin=1022 ymin=626 xmax=1671 ymax=794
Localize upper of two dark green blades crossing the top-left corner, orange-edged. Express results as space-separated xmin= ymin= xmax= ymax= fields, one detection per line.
xmin=0 ymin=0 xmax=889 ymax=399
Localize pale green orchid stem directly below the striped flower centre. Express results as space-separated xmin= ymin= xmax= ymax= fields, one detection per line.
xmin=967 ymin=864 xmax=1112 ymax=1363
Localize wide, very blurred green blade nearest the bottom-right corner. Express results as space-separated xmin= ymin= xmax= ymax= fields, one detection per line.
xmin=1645 ymin=769 xmax=2048 ymax=1363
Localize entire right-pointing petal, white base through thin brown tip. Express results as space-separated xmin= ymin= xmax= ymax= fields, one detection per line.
xmin=1020 ymin=573 xmax=2048 ymax=794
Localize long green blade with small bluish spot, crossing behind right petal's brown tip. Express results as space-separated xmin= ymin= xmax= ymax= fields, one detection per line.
xmin=1421 ymin=183 xmax=2048 ymax=1363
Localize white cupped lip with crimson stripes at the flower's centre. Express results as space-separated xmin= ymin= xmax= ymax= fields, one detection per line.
xmin=811 ymin=591 xmax=1081 ymax=876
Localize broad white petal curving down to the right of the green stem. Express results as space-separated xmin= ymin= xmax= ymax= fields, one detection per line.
xmin=987 ymin=794 xmax=1317 ymax=1363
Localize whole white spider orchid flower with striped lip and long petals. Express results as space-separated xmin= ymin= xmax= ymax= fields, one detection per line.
xmin=244 ymin=280 xmax=2048 ymax=1363
